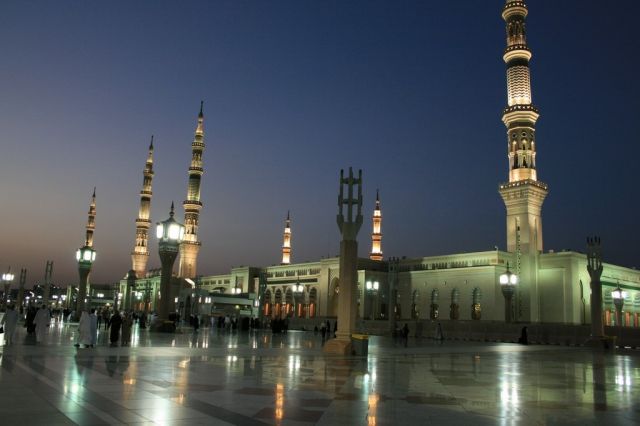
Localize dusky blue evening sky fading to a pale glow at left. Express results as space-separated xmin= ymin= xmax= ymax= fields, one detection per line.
xmin=0 ymin=0 xmax=640 ymax=287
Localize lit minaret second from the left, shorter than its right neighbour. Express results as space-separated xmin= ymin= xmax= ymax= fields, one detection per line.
xmin=131 ymin=135 xmax=153 ymax=278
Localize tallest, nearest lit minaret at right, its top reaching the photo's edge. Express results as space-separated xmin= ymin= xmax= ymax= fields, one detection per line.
xmin=499 ymin=0 xmax=548 ymax=321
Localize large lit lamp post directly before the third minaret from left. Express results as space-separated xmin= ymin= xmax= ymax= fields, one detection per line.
xmin=153 ymin=203 xmax=184 ymax=332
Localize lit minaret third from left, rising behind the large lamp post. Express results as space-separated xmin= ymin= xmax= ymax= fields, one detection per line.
xmin=178 ymin=102 xmax=204 ymax=278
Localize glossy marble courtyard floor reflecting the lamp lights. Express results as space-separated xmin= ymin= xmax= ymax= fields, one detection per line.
xmin=0 ymin=325 xmax=640 ymax=426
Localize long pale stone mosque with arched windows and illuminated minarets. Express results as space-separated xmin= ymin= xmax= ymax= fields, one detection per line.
xmin=120 ymin=0 xmax=640 ymax=327
